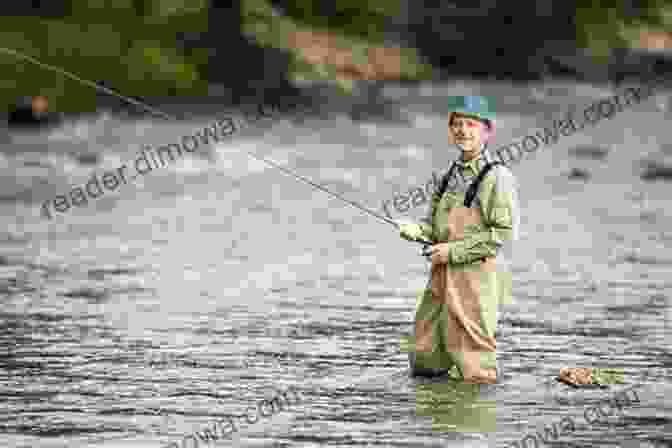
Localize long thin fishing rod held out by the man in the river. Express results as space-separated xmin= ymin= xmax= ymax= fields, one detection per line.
xmin=0 ymin=48 xmax=432 ymax=256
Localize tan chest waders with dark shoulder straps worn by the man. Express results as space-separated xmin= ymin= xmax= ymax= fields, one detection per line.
xmin=409 ymin=162 xmax=503 ymax=381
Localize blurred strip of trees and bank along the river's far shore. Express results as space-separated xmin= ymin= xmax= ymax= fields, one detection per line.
xmin=0 ymin=0 xmax=672 ymax=117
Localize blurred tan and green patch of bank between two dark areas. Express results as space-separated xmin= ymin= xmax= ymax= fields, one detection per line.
xmin=243 ymin=0 xmax=431 ymax=93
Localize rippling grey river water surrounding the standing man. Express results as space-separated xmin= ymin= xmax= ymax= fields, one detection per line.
xmin=0 ymin=82 xmax=672 ymax=448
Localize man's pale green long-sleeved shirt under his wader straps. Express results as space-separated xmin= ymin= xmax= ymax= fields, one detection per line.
xmin=420 ymin=149 xmax=519 ymax=264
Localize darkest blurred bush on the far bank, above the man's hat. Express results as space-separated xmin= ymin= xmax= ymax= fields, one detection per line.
xmin=408 ymin=0 xmax=576 ymax=81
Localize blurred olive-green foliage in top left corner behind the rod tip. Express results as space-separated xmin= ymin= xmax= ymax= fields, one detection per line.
xmin=0 ymin=0 xmax=207 ymax=112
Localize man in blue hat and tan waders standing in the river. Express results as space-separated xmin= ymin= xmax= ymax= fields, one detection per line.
xmin=399 ymin=96 xmax=518 ymax=384
